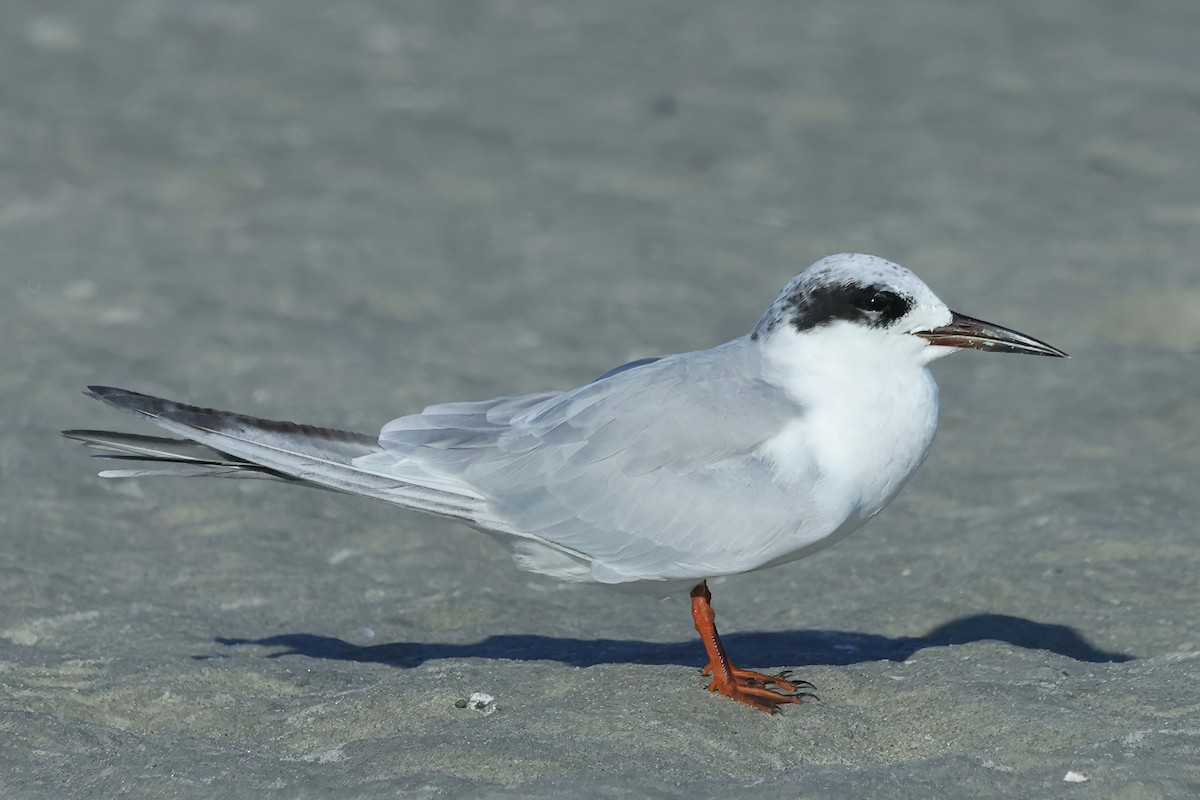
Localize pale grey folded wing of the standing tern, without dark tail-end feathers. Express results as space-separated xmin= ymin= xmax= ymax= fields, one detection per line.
xmin=355 ymin=339 xmax=803 ymax=583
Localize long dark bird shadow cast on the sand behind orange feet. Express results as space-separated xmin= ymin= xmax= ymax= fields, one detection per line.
xmin=206 ymin=614 xmax=1135 ymax=669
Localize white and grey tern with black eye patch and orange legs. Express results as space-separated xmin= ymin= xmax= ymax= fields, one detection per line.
xmin=64 ymin=253 xmax=1067 ymax=712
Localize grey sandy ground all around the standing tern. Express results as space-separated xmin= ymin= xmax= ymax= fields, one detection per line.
xmin=0 ymin=0 xmax=1200 ymax=796
